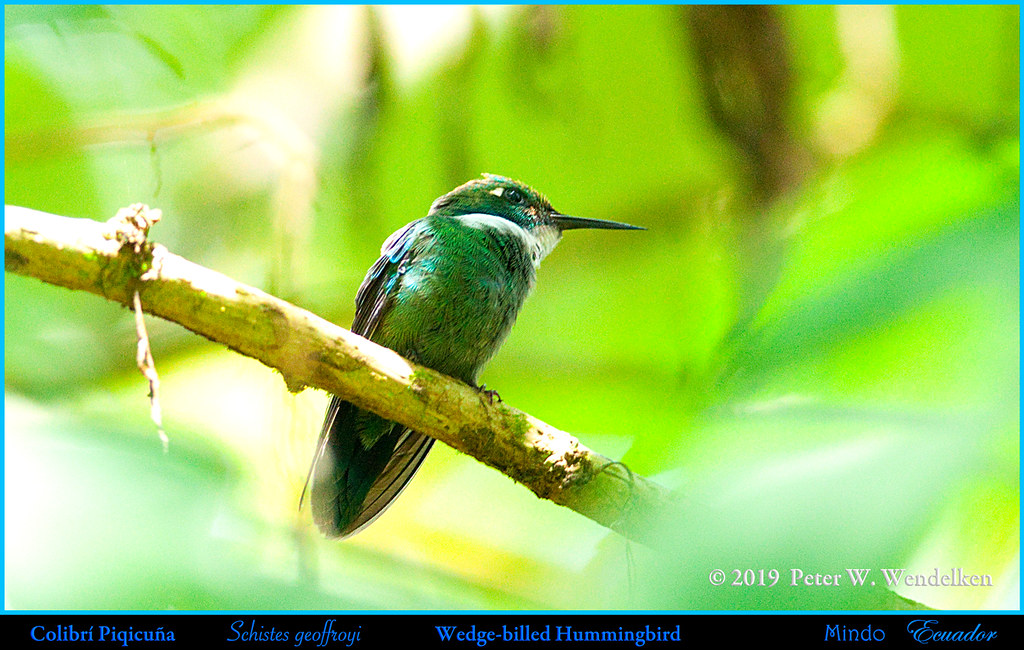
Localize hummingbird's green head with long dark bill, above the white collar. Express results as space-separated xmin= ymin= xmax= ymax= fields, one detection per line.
xmin=429 ymin=174 xmax=643 ymax=236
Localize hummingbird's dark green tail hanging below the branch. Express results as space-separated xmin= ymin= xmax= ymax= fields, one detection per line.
xmin=309 ymin=397 xmax=434 ymax=537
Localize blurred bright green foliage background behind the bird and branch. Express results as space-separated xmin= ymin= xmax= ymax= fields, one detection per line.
xmin=4 ymin=5 xmax=1020 ymax=610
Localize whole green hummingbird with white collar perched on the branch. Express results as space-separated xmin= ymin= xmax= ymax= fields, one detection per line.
xmin=307 ymin=174 xmax=644 ymax=538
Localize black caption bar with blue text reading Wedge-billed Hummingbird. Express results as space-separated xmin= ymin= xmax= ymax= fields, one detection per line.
xmin=3 ymin=612 xmax=1021 ymax=650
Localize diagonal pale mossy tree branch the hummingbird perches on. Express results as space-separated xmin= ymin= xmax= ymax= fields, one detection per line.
xmin=4 ymin=206 xmax=676 ymax=546
